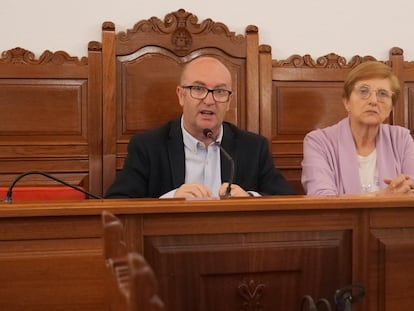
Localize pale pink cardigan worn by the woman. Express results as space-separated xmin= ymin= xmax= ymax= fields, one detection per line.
xmin=302 ymin=118 xmax=414 ymax=195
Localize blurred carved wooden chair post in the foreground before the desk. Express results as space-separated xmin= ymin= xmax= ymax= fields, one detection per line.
xmin=102 ymin=211 xmax=164 ymax=311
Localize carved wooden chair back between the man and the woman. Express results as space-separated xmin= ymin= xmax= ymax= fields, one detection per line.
xmin=260 ymin=46 xmax=382 ymax=194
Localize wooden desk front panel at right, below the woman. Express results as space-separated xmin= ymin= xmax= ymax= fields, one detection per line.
xmin=367 ymin=208 xmax=414 ymax=311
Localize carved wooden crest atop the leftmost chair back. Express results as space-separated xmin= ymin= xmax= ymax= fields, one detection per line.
xmin=0 ymin=47 xmax=88 ymax=65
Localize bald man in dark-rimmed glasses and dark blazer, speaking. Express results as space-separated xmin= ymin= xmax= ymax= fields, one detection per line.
xmin=106 ymin=57 xmax=294 ymax=198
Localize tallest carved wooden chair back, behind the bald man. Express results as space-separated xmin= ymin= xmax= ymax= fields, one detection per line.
xmin=102 ymin=9 xmax=259 ymax=191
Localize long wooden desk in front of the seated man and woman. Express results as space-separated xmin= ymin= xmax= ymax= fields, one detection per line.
xmin=0 ymin=197 xmax=414 ymax=311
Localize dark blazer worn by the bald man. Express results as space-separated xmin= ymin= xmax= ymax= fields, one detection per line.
xmin=105 ymin=119 xmax=294 ymax=198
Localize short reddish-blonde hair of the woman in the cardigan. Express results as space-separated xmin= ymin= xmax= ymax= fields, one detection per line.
xmin=342 ymin=61 xmax=401 ymax=104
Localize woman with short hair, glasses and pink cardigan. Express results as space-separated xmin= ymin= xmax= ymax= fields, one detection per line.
xmin=302 ymin=61 xmax=414 ymax=195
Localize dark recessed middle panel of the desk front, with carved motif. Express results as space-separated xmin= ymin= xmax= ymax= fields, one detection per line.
xmin=145 ymin=231 xmax=351 ymax=311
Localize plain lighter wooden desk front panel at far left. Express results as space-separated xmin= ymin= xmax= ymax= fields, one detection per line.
xmin=0 ymin=217 xmax=109 ymax=311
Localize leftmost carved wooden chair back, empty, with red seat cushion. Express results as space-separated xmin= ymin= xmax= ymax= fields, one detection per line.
xmin=0 ymin=42 xmax=102 ymax=195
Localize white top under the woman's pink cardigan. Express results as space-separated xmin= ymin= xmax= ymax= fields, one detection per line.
xmin=358 ymin=149 xmax=379 ymax=192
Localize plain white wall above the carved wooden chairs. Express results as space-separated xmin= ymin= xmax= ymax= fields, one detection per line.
xmin=0 ymin=0 xmax=414 ymax=61
